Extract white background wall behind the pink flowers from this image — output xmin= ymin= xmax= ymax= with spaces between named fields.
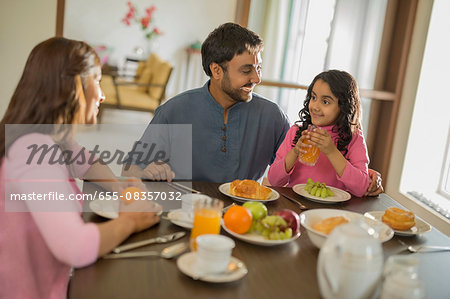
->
xmin=64 ymin=0 xmax=236 ymax=97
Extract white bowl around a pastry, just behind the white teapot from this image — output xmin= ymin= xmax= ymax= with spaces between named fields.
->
xmin=300 ymin=209 xmax=394 ymax=248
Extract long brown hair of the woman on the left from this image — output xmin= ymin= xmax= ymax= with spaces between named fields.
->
xmin=0 ymin=37 xmax=100 ymax=160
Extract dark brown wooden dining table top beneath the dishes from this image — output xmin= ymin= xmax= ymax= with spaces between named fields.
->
xmin=68 ymin=181 xmax=450 ymax=299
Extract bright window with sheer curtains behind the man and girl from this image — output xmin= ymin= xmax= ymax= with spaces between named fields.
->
xmin=248 ymin=0 xmax=387 ymax=132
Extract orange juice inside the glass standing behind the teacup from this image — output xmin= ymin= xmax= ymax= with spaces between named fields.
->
xmin=190 ymin=209 xmax=220 ymax=251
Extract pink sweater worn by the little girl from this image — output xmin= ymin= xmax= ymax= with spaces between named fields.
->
xmin=268 ymin=125 xmax=369 ymax=197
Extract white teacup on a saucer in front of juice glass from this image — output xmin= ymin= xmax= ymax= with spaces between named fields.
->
xmin=196 ymin=234 xmax=235 ymax=274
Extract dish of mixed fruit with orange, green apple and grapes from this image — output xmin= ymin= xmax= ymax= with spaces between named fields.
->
xmin=222 ymin=202 xmax=300 ymax=246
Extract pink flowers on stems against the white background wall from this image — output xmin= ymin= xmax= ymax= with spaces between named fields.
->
xmin=121 ymin=2 xmax=163 ymax=54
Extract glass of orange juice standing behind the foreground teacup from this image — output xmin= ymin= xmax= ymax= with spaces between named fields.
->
xmin=190 ymin=197 xmax=223 ymax=251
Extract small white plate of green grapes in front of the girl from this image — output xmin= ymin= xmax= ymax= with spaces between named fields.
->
xmin=292 ymin=179 xmax=352 ymax=203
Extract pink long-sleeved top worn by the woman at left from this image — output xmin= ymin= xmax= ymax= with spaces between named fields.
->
xmin=0 ymin=133 xmax=100 ymax=298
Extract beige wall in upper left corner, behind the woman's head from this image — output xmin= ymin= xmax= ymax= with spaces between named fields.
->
xmin=0 ymin=0 xmax=57 ymax=117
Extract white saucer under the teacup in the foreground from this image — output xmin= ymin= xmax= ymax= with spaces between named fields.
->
xmin=177 ymin=252 xmax=248 ymax=283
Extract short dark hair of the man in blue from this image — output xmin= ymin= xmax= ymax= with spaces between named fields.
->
xmin=202 ymin=23 xmax=263 ymax=77
